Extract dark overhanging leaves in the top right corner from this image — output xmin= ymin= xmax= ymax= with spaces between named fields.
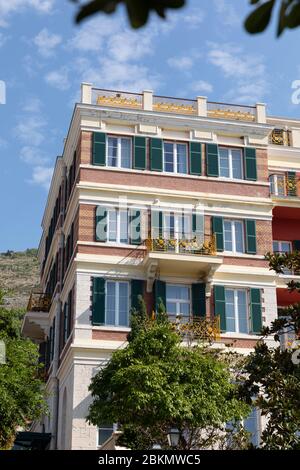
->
xmin=245 ymin=0 xmax=300 ymax=37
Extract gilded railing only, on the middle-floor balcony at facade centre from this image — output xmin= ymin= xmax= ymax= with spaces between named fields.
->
xmin=146 ymin=235 xmax=217 ymax=255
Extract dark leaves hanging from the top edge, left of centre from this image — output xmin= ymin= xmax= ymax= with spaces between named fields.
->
xmin=72 ymin=0 xmax=185 ymax=28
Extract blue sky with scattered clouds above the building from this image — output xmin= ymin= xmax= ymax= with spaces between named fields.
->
xmin=0 ymin=0 xmax=300 ymax=252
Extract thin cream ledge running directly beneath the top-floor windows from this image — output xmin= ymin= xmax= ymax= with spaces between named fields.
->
xmin=80 ymin=164 xmax=270 ymax=188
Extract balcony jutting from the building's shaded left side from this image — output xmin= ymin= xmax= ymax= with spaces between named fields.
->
xmin=22 ymin=292 xmax=51 ymax=342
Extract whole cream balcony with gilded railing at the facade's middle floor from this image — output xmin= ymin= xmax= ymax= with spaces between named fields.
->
xmin=144 ymin=235 xmax=222 ymax=286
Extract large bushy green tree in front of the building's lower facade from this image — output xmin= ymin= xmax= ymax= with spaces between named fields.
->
xmin=88 ymin=312 xmax=249 ymax=449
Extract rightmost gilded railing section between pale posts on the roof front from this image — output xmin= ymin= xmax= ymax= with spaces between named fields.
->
xmin=207 ymin=101 xmax=256 ymax=122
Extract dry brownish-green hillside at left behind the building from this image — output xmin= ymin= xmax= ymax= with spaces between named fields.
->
xmin=0 ymin=248 xmax=39 ymax=308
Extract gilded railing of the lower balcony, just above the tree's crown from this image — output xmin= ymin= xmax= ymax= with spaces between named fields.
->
xmin=168 ymin=315 xmax=221 ymax=342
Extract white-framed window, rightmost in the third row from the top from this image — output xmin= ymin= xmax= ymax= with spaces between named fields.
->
xmin=225 ymin=289 xmax=249 ymax=333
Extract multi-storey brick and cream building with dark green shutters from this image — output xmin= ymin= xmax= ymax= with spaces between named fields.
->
xmin=23 ymin=84 xmax=300 ymax=449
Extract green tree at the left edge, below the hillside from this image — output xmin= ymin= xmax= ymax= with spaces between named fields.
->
xmin=0 ymin=291 xmax=46 ymax=449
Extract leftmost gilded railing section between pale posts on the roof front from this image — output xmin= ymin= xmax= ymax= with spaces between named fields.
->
xmin=92 ymin=88 xmax=143 ymax=109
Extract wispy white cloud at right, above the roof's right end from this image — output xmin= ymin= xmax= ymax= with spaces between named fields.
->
xmin=207 ymin=43 xmax=268 ymax=104
